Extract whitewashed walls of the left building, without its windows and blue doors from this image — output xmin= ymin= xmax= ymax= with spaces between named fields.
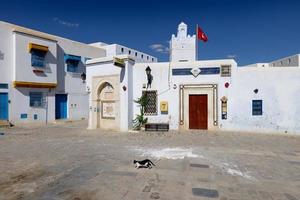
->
xmin=0 ymin=21 xmax=105 ymax=123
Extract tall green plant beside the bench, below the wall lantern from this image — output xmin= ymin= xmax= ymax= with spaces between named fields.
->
xmin=133 ymin=93 xmax=149 ymax=130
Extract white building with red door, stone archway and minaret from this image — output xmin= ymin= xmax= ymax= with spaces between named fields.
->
xmin=87 ymin=23 xmax=300 ymax=133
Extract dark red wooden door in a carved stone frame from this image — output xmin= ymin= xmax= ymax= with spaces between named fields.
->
xmin=189 ymin=94 xmax=207 ymax=130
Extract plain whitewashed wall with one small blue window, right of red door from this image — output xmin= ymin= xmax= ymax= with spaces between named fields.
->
xmin=222 ymin=67 xmax=300 ymax=133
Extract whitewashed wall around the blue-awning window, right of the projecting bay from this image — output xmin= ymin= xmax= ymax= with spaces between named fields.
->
xmin=56 ymin=38 xmax=105 ymax=120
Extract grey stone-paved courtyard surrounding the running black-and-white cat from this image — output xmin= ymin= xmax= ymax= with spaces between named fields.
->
xmin=0 ymin=121 xmax=300 ymax=200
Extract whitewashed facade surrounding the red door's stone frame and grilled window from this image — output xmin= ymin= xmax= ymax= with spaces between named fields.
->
xmin=133 ymin=59 xmax=237 ymax=130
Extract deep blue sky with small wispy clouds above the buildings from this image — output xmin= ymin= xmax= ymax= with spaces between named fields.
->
xmin=0 ymin=0 xmax=300 ymax=66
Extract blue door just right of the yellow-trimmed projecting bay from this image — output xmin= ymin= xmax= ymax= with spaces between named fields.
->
xmin=55 ymin=94 xmax=68 ymax=119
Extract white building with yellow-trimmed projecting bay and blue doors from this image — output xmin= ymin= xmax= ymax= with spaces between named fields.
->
xmin=0 ymin=21 xmax=157 ymax=124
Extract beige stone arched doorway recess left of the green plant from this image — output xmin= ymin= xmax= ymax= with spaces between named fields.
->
xmin=97 ymin=82 xmax=116 ymax=129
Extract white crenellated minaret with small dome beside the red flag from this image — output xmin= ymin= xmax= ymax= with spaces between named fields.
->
xmin=170 ymin=22 xmax=197 ymax=62
